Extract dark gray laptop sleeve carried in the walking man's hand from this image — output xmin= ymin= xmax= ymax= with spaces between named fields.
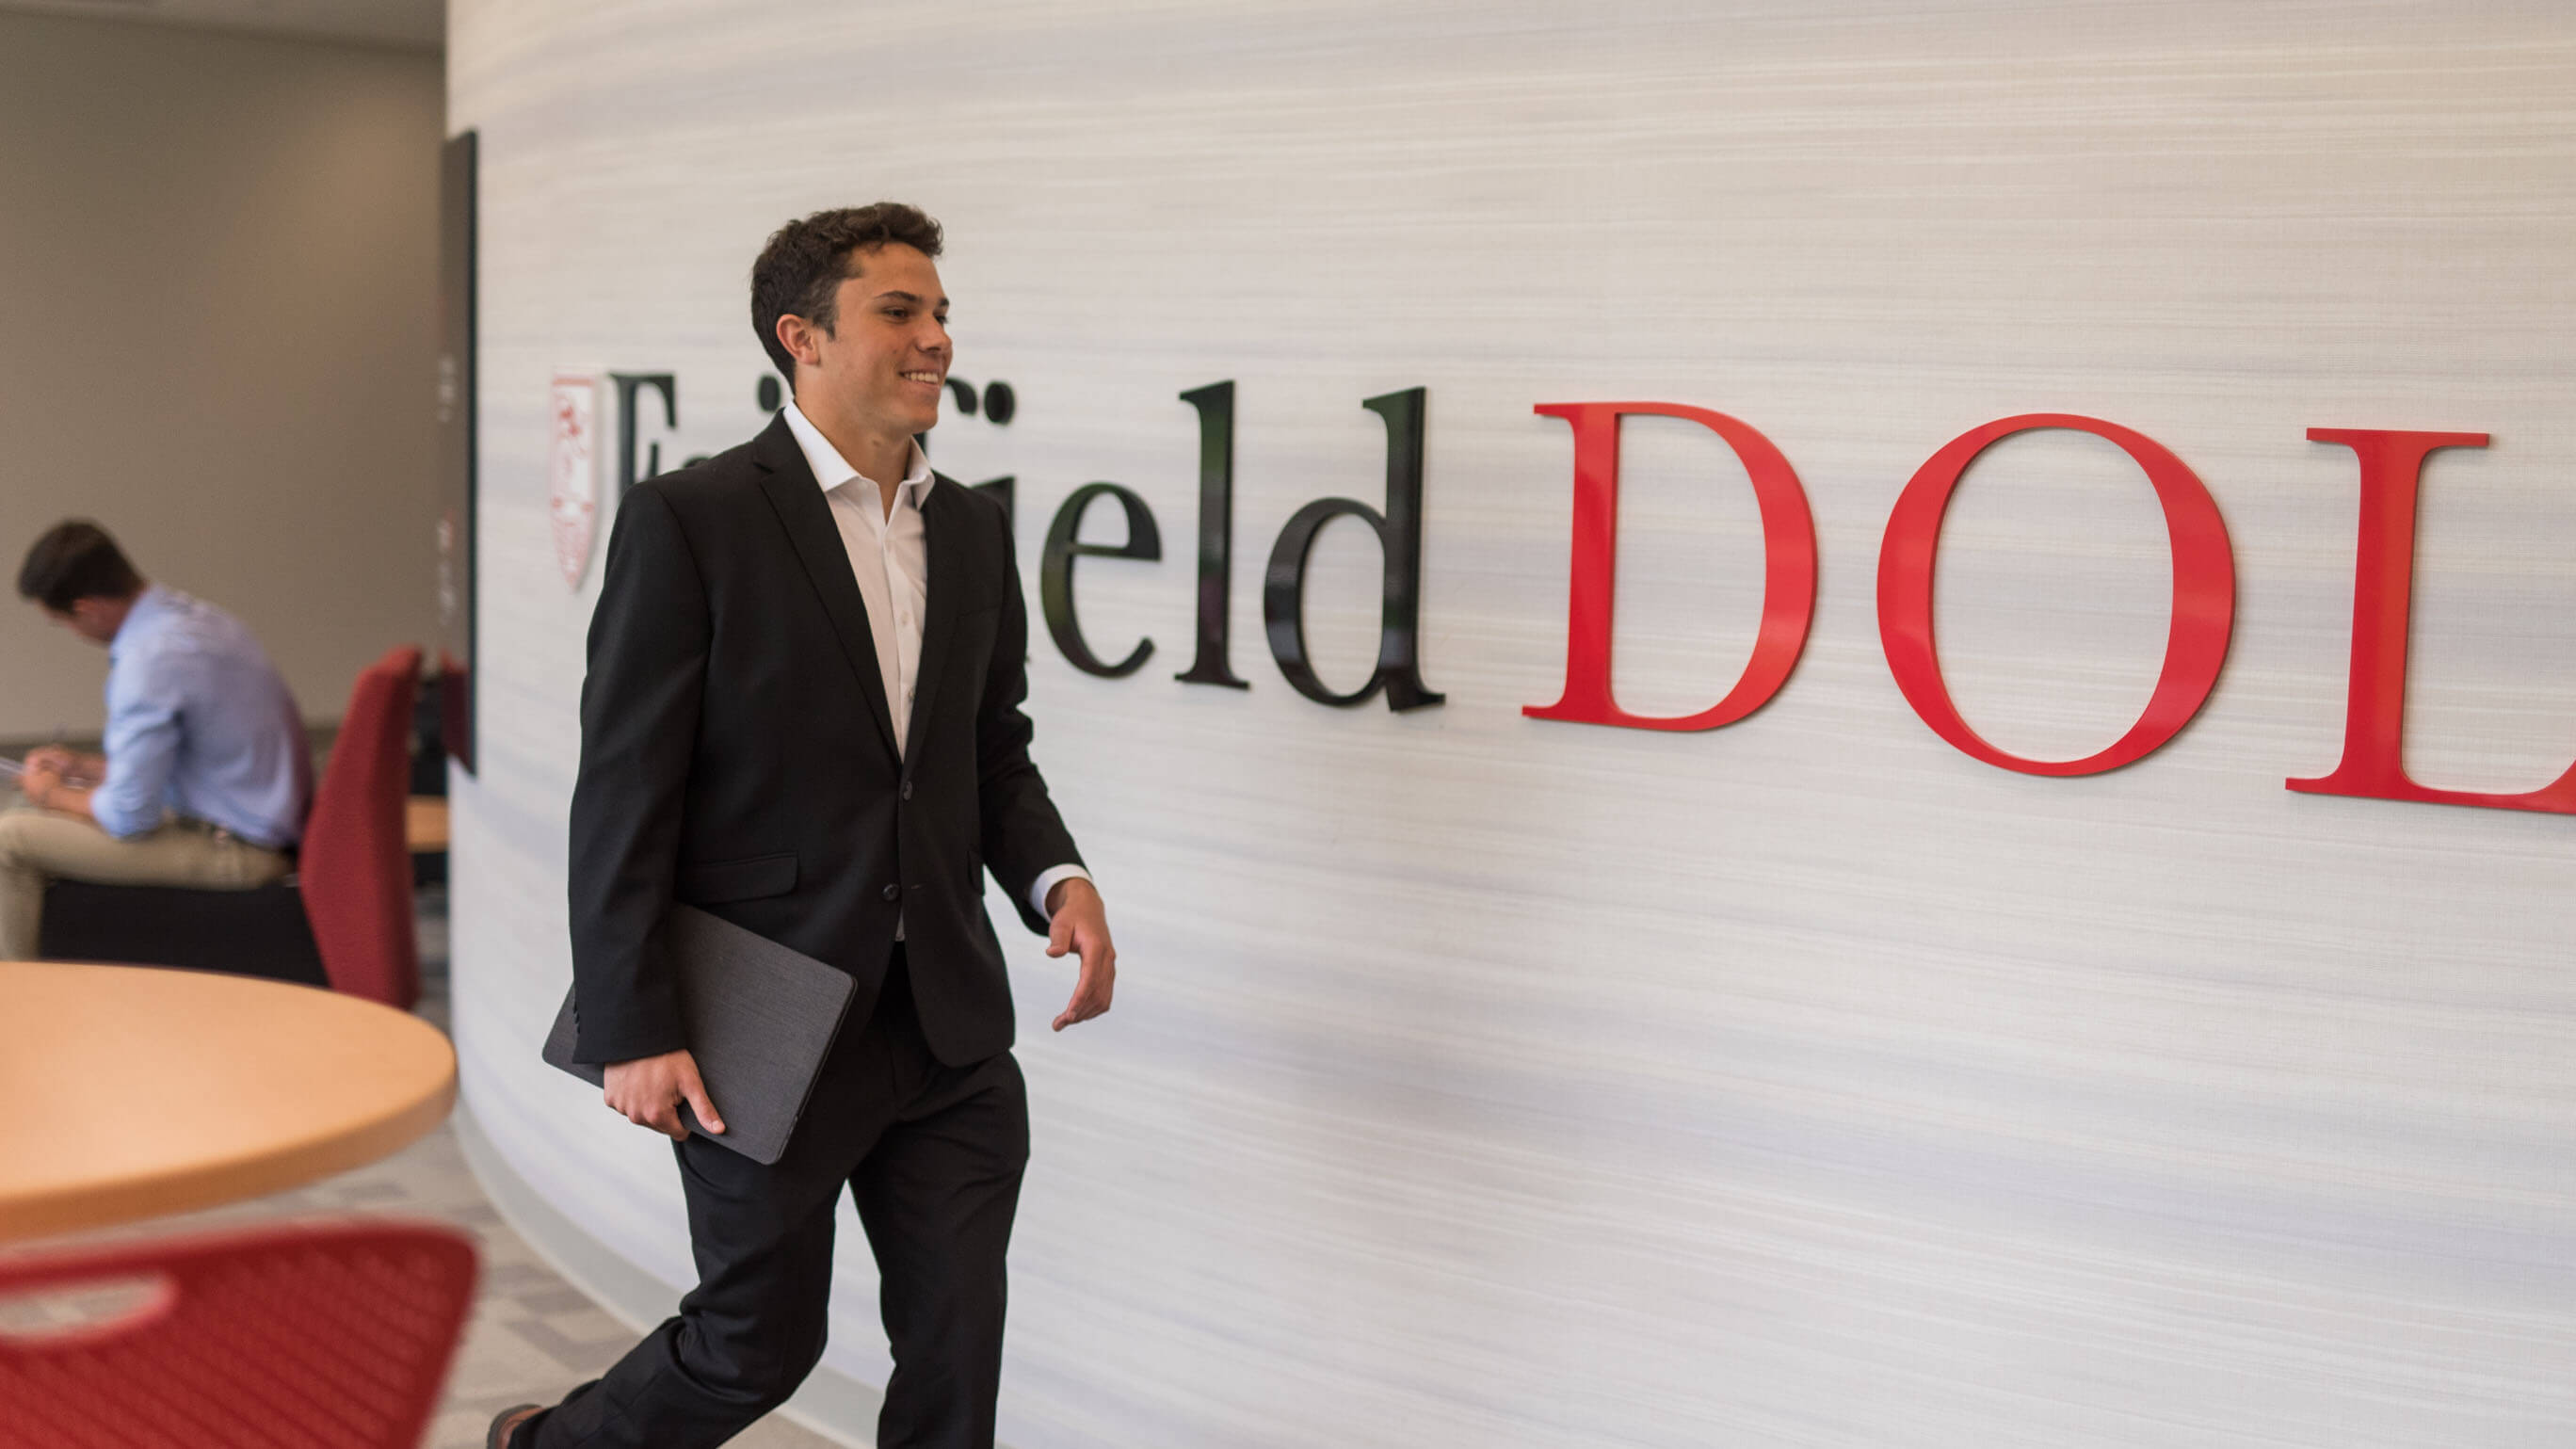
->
xmin=546 ymin=905 xmax=858 ymax=1163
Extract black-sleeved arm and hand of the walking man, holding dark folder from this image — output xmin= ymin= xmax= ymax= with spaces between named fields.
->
xmin=567 ymin=485 xmax=724 ymax=1137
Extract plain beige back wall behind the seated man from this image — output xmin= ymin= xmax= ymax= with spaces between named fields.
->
xmin=0 ymin=15 xmax=443 ymax=740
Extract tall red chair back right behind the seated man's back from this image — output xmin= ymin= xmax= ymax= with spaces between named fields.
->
xmin=297 ymin=645 xmax=420 ymax=1010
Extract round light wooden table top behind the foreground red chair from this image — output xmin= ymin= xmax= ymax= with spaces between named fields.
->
xmin=0 ymin=961 xmax=456 ymax=1243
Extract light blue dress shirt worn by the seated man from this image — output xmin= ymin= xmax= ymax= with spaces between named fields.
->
xmin=90 ymin=586 xmax=314 ymax=851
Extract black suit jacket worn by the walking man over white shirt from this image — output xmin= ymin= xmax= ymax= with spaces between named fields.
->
xmin=570 ymin=418 xmax=1082 ymax=1065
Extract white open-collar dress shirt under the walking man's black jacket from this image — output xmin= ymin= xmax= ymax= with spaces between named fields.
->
xmin=783 ymin=402 xmax=1092 ymax=912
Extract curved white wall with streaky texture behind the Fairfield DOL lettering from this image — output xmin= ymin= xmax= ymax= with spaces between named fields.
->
xmin=448 ymin=0 xmax=2576 ymax=1449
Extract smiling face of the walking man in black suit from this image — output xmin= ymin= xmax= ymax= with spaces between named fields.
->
xmin=798 ymin=242 xmax=948 ymax=436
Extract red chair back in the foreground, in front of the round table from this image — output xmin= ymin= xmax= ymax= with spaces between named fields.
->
xmin=0 ymin=1222 xmax=474 ymax=1449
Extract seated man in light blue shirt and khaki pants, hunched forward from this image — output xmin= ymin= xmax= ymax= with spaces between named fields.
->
xmin=0 ymin=521 xmax=312 ymax=961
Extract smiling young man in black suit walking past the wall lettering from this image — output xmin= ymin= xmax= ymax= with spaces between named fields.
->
xmin=492 ymin=203 xmax=1116 ymax=1449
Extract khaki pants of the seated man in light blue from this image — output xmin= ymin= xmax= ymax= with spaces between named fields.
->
xmin=0 ymin=804 xmax=286 ymax=961
